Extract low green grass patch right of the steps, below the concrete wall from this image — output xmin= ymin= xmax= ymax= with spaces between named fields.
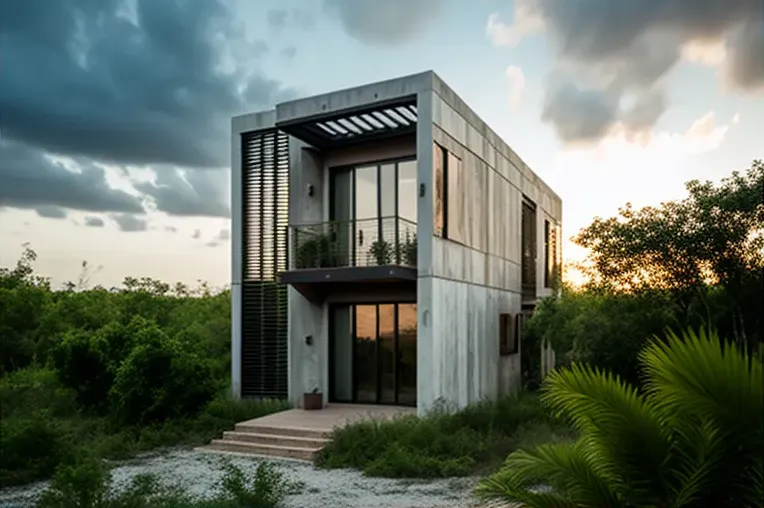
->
xmin=318 ymin=394 xmax=567 ymax=478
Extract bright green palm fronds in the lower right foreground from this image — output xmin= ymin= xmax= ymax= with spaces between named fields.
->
xmin=477 ymin=329 xmax=764 ymax=508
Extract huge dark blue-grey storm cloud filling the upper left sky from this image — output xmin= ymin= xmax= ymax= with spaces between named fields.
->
xmin=0 ymin=0 xmax=294 ymax=171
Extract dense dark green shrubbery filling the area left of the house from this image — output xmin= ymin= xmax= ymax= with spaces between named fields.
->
xmin=0 ymin=253 xmax=284 ymax=486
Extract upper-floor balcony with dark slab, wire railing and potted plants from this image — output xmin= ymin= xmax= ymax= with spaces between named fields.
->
xmin=281 ymin=216 xmax=417 ymax=302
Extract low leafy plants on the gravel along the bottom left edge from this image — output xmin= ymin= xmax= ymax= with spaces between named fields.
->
xmin=36 ymin=459 xmax=303 ymax=508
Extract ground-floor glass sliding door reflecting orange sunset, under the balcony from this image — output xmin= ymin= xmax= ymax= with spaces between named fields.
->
xmin=329 ymin=303 xmax=417 ymax=406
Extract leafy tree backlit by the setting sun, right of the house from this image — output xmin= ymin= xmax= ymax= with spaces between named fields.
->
xmin=574 ymin=161 xmax=764 ymax=346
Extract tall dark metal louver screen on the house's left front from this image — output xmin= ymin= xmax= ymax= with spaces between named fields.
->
xmin=241 ymin=129 xmax=289 ymax=398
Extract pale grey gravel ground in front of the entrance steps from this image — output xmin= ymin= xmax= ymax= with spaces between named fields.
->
xmin=0 ymin=450 xmax=490 ymax=508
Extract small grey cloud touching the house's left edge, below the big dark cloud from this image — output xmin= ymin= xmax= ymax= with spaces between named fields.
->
xmin=133 ymin=168 xmax=231 ymax=217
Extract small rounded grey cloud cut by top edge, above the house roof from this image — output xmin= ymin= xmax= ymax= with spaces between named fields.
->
xmin=324 ymin=0 xmax=445 ymax=45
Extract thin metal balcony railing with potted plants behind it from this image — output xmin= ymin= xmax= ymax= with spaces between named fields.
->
xmin=289 ymin=217 xmax=417 ymax=270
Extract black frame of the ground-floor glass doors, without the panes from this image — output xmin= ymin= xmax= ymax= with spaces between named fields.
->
xmin=328 ymin=300 xmax=419 ymax=407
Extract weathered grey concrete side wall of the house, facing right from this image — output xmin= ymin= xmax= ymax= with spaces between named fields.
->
xmin=418 ymin=74 xmax=562 ymax=414
